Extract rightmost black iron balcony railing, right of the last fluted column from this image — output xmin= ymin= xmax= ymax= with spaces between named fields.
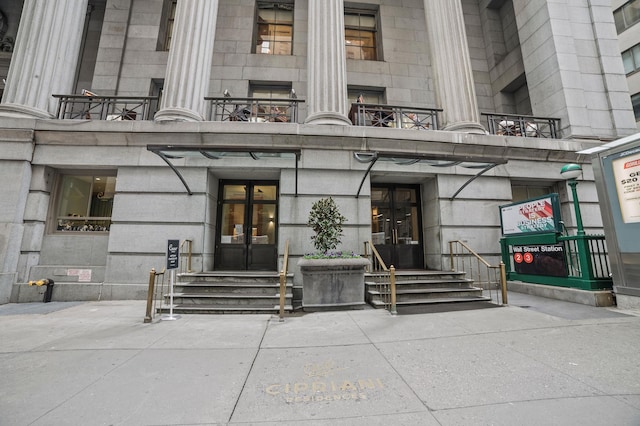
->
xmin=482 ymin=113 xmax=560 ymax=139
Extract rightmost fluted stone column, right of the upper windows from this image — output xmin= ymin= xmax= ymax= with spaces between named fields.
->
xmin=424 ymin=0 xmax=485 ymax=133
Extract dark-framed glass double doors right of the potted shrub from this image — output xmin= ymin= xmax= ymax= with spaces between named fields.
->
xmin=371 ymin=185 xmax=424 ymax=269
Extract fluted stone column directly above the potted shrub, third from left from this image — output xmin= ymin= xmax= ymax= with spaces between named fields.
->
xmin=306 ymin=0 xmax=351 ymax=125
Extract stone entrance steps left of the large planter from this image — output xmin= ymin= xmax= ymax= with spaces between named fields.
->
xmin=159 ymin=271 xmax=293 ymax=314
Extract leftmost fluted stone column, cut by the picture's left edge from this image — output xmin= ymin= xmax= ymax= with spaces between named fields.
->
xmin=0 ymin=0 xmax=88 ymax=118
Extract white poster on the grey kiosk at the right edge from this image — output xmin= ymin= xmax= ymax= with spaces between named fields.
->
xmin=611 ymin=153 xmax=640 ymax=223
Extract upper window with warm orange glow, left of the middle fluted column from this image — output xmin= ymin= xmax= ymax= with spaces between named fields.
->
xmin=255 ymin=1 xmax=293 ymax=55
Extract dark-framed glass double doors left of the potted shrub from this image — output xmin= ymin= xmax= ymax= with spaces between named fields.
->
xmin=215 ymin=181 xmax=278 ymax=271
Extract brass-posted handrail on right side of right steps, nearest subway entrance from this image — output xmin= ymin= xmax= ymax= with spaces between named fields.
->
xmin=449 ymin=240 xmax=507 ymax=305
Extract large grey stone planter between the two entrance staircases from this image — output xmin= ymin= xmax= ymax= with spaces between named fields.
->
xmin=298 ymin=258 xmax=369 ymax=311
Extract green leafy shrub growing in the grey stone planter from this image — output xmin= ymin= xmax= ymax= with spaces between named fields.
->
xmin=307 ymin=197 xmax=347 ymax=253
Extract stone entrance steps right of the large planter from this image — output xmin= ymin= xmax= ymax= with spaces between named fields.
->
xmin=365 ymin=270 xmax=491 ymax=309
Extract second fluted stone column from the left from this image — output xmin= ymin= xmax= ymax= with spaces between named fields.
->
xmin=155 ymin=0 xmax=218 ymax=121
